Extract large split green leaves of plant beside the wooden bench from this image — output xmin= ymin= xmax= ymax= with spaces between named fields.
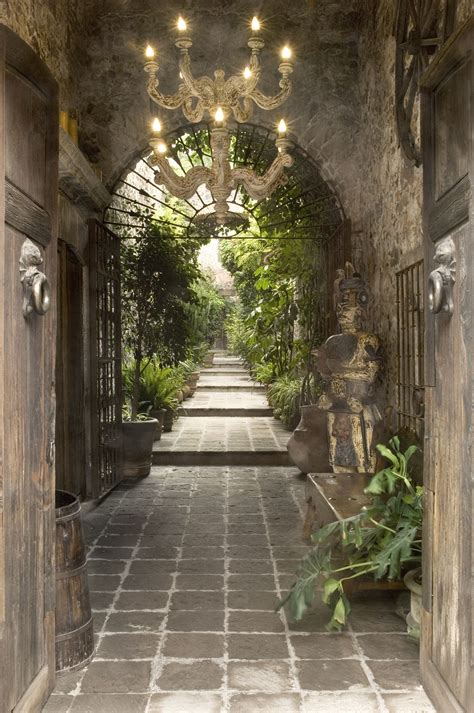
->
xmin=279 ymin=436 xmax=423 ymax=631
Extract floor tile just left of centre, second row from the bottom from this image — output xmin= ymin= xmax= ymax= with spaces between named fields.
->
xmin=155 ymin=661 xmax=224 ymax=691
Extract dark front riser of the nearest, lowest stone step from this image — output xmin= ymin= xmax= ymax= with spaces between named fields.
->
xmin=152 ymin=450 xmax=291 ymax=466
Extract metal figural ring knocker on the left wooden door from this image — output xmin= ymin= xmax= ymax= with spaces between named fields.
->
xmin=19 ymin=238 xmax=51 ymax=317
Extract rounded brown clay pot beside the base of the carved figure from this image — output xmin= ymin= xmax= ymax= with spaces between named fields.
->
xmin=287 ymin=404 xmax=332 ymax=473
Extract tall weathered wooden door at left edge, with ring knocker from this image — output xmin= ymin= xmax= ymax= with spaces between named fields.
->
xmin=0 ymin=26 xmax=58 ymax=713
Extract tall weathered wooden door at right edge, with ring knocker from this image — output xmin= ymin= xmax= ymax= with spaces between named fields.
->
xmin=421 ymin=18 xmax=474 ymax=713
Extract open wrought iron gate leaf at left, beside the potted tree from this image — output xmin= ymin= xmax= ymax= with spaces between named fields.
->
xmin=89 ymin=220 xmax=122 ymax=498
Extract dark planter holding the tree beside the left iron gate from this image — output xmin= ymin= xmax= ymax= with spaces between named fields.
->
xmin=122 ymin=418 xmax=158 ymax=478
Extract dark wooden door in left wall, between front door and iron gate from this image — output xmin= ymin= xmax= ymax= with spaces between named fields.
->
xmin=56 ymin=240 xmax=87 ymax=499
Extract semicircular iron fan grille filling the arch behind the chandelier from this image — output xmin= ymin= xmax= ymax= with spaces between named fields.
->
xmin=105 ymin=123 xmax=344 ymax=241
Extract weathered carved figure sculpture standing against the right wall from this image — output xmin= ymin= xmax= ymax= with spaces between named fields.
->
xmin=314 ymin=263 xmax=381 ymax=473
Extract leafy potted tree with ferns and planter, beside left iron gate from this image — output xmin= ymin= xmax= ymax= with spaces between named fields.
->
xmin=120 ymin=215 xmax=201 ymax=476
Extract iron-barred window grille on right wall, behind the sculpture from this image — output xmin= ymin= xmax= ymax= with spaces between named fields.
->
xmin=396 ymin=260 xmax=425 ymax=436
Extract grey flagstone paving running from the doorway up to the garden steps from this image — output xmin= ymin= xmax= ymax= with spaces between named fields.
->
xmin=44 ymin=361 xmax=434 ymax=713
